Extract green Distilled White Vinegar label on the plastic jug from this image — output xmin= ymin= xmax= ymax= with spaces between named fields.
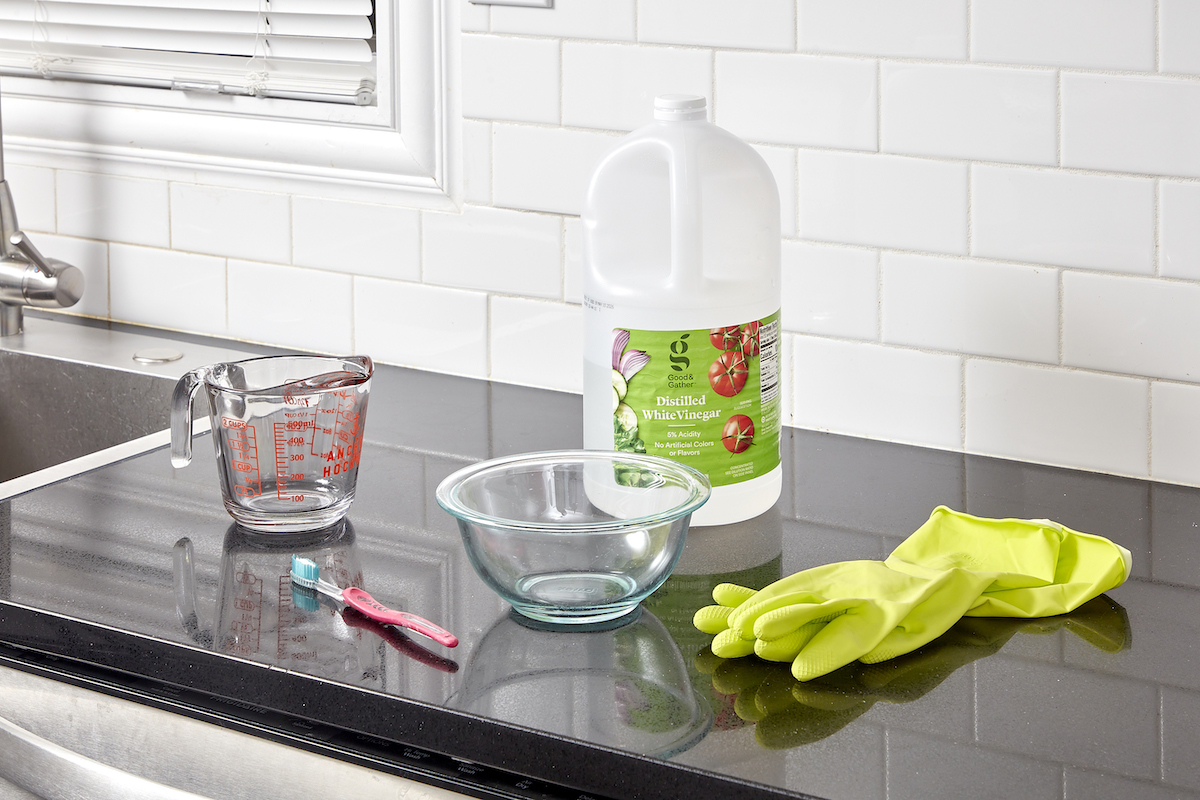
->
xmin=612 ymin=312 xmax=780 ymax=486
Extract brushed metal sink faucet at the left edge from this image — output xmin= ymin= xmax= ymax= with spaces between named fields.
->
xmin=0 ymin=89 xmax=83 ymax=336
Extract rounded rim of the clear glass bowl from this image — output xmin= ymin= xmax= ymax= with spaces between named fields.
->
xmin=436 ymin=450 xmax=713 ymax=535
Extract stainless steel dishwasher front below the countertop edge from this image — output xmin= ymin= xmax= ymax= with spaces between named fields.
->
xmin=0 ymin=667 xmax=466 ymax=800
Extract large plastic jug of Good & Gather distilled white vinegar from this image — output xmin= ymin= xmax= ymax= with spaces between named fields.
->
xmin=582 ymin=95 xmax=782 ymax=525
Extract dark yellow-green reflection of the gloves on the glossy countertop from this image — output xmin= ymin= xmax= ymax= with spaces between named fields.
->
xmin=696 ymin=595 xmax=1132 ymax=750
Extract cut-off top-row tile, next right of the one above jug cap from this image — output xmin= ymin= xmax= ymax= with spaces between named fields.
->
xmin=798 ymin=0 xmax=967 ymax=60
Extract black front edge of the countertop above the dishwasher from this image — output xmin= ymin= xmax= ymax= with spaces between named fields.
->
xmin=0 ymin=601 xmax=815 ymax=800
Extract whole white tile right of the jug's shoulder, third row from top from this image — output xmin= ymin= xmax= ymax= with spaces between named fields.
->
xmin=798 ymin=150 xmax=967 ymax=254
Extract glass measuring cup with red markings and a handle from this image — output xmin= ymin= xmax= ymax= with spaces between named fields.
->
xmin=170 ymin=355 xmax=374 ymax=533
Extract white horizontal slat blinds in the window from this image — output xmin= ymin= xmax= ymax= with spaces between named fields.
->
xmin=0 ymin=0 xmax=376 ymax=104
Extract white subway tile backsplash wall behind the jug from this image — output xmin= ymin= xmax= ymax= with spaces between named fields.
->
xmin=8 ymin=0 xmax=1200 ymax=485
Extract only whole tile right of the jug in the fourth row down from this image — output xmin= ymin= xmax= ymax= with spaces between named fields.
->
xmin=881 ymin=253 xmax=1058 ymax=362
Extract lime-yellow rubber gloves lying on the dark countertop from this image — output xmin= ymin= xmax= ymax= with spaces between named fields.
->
xmin=694 ymin=506 xmax=1130 ymax=680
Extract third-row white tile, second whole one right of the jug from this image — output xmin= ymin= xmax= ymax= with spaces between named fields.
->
xmin=971 ymin=166 xmax=1154 ymax=275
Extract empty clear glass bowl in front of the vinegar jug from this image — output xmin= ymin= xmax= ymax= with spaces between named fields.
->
xmin=437 ymin=450 xmax=712 ymax=624
